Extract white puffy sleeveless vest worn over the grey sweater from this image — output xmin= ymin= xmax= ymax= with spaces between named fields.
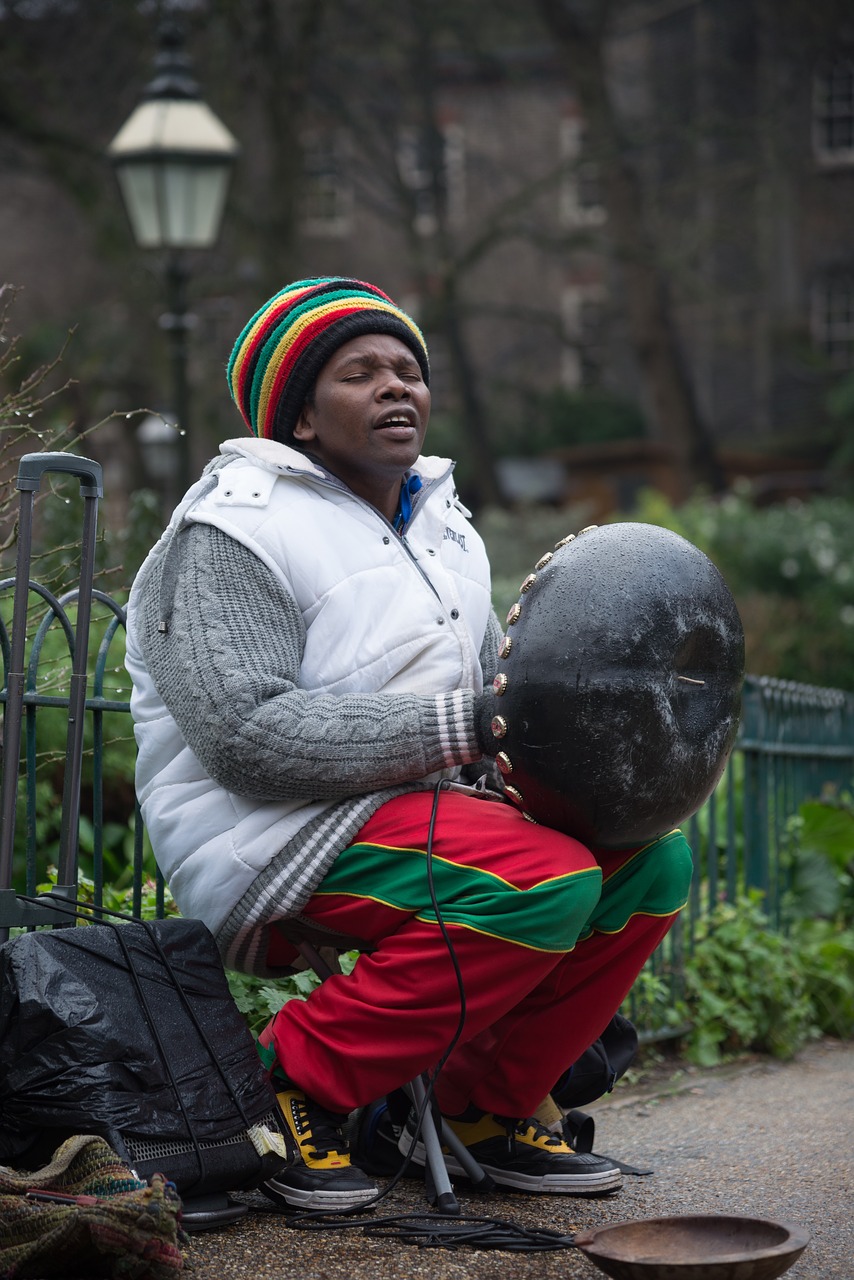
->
xmin=127 ymin=439 xmax=490 ymax=933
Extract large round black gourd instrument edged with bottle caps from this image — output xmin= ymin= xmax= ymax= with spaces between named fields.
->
xmin=492 ymin=522 xmax=744 ymax=847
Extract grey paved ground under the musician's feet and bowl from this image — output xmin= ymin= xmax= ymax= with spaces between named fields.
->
xmin=188 ymin=1042 xmax=854 ymax=1280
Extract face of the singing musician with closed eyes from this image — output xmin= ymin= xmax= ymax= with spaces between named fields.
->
xmin=293 ymin=333 xmax=430 ymax=520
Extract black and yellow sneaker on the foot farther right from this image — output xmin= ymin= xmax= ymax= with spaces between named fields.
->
xmin=399 ymin=1107 xmax=622 ymax=1196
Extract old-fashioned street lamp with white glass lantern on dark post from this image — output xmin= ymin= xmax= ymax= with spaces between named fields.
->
xmin=108 ymin=22 xmax=238 ymax=493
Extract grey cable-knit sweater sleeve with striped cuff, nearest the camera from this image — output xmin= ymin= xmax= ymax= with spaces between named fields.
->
xmin=136 ymin=525 xmax=491 ymax=800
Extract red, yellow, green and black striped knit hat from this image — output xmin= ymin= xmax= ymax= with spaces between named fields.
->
xmin=227 ymin=275 xmax=430 ymax=444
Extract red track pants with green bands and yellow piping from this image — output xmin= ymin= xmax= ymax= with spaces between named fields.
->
xmin=270 ymin=791 xmax=691 ymax=1116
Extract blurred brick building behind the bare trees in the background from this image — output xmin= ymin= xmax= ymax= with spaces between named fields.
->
xmin=0 ymin=0 xmax=854 ymax=508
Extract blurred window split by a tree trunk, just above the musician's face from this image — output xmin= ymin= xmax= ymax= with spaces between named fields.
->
xmin=397 ymin=124 xmax=466 ymax=236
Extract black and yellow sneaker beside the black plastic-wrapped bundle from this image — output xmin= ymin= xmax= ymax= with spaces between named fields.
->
xmin=260 ymin=1079 xmax=379 ymax=1212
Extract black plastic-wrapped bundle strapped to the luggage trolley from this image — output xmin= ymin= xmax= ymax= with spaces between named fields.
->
xmin=0 ymin=919 xmax=287 ymax=1196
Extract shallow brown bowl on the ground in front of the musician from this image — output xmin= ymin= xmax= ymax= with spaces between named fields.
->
xmin=575 ymin=1213 xmax=809 ymax=1280
